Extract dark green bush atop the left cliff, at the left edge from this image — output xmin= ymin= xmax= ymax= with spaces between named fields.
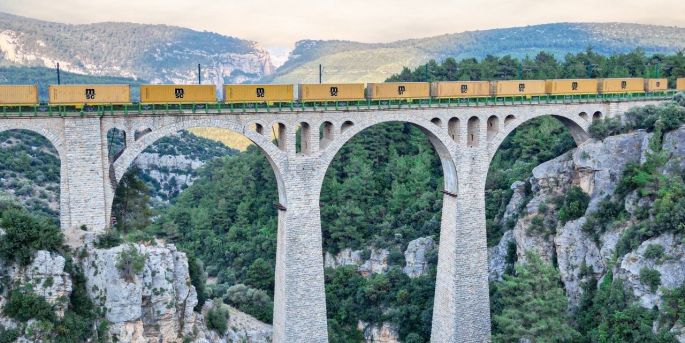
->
xmin=0 ymin=209 xmax=64 ymax=266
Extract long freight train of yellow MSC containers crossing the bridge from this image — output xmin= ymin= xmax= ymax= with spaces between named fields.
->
xmin=0 ymin=78 xmax=685 ymax=112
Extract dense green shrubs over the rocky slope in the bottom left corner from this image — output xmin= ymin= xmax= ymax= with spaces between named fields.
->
xmin=0 ymin=193 xmax=108 ymax=343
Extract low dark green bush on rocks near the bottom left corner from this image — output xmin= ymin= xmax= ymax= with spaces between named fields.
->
xmin=2 ymin=289 xmax=56 ymax=322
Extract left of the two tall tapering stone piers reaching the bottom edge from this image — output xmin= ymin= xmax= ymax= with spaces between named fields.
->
xmin=273 ymin=161 xmax=328 ymax=343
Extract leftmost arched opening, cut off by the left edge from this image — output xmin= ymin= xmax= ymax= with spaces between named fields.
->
xmin=0 ymin=129 xmax=60 ymax=225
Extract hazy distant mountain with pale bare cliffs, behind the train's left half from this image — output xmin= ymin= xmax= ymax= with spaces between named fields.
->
xmin=0 ymin=13 xmax=275 ymax=89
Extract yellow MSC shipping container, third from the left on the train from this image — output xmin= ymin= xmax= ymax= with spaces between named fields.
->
xmin=140 ymin=85 xmax=216 ymax=104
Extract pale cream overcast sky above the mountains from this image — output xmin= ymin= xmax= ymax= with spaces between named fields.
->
xmin=0 ymin=0 xmax=685 ymax=48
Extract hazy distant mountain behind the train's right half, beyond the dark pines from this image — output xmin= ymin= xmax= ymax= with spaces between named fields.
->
xmin=264 ymin=23 xmax=685 ymax=83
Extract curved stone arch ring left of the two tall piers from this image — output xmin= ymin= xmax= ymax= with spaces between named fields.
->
xmin=111 ymin=118 xmax=287 ymax=212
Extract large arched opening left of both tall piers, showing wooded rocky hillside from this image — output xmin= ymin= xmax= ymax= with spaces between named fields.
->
xmin=111 ymin=125 xmax=287 ymax=330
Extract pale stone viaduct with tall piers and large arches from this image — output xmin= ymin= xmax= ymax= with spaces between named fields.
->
xmin=0 ymin=101 xmax=656 ymax=343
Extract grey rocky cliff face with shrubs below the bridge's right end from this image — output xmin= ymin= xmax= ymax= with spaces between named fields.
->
xmin=490 ymin=127 xmax=685 ymax=326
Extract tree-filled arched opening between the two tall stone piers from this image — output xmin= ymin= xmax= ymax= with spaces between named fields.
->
xmin=320 ymin=121 xmax=457 ymax=342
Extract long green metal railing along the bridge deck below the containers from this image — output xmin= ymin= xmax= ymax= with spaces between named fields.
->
xmin=1 ymin=91 xmax=678 ymax=117
